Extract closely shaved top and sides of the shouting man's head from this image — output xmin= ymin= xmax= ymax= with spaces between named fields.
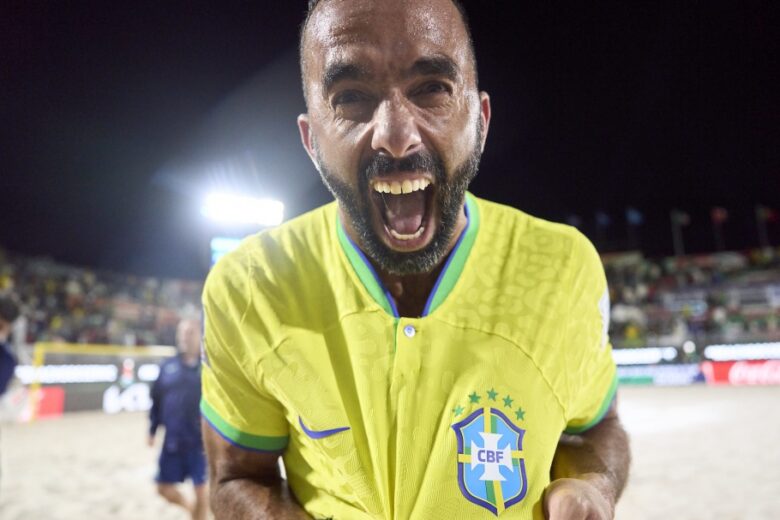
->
xmin=299 ymin=0 xmax=478 ymax=106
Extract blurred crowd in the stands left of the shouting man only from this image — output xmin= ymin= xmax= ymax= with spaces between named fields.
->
xmin=0 ymin=249 xmax=202 ymax=346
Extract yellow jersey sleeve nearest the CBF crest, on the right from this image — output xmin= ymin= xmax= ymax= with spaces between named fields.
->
xmin=565 ymin=233 xmax=617 ymax=434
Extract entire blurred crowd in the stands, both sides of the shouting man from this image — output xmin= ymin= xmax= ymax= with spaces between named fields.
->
xmin=0 ymin=245 xmax=780 ymax=348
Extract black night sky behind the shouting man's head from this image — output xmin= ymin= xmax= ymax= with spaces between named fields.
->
xmin=0 ymin=0 xmax=780 ymax=278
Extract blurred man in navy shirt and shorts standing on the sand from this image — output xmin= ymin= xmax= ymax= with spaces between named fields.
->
xmin=149 ymin=319 xmax=208 ymax=520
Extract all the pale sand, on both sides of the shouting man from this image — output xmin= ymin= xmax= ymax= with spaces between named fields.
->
xmin=0 ymin=386 xmax=780 ymax=520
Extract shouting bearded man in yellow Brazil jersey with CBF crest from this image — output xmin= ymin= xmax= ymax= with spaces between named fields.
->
xmin=201 ymin=0 xmax=629 ymax=520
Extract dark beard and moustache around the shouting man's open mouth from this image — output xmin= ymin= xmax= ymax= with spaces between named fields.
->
xmin=312 ymin=120 xmax=482 ymax=275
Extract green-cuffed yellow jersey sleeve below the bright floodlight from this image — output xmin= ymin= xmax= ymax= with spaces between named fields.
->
xmin=200 ymin=257 xmax=288 ymax=452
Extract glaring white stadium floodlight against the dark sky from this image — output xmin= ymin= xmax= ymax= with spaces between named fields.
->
xmin=200 ymin=193 xmax=284 ymax=226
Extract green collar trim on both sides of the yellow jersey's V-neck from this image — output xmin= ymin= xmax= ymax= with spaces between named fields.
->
xmin=336 ymin=193 xmax=479 ymax=318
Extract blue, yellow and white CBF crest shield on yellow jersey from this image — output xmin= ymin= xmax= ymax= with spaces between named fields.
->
xmin=452 ymin=406 xmax=528 ymax=516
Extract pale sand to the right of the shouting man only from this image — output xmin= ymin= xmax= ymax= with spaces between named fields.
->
xmin=617 ymin=386 xmax=780 ymax=520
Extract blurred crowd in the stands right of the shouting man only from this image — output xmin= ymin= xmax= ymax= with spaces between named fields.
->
xmin=603 ymin=249 xmax=780 ymax=347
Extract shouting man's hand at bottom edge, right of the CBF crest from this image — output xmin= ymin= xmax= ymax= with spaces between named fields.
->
xmin=544 ymin=478 xmax=614 ymax=520
